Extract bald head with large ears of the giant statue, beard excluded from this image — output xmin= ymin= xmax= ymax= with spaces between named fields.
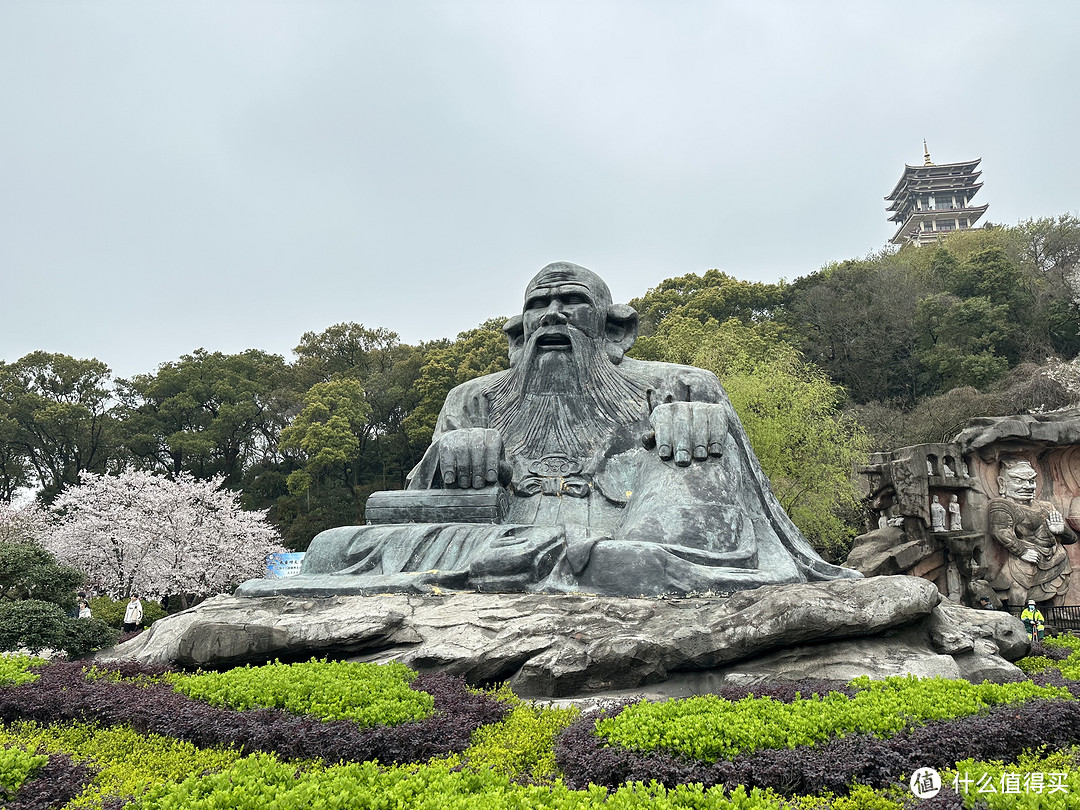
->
xmin=503 ymin=261 xmax=637 ymax=363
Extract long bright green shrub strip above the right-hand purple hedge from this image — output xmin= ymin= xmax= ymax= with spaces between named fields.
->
xmin=596 ymin=677 xmax=1071 ymax=762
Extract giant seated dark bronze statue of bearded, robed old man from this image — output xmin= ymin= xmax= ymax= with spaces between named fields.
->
xmin=238 ymin=262 xmax=861 ymax=596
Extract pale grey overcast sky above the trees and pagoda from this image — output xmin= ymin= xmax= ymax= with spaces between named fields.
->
xmin=0 ymin=0 xmax=1080 ymax=376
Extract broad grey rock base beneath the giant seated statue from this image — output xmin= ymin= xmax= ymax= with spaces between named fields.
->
xmin=97 ymin=577 xmax=1028 ymax=699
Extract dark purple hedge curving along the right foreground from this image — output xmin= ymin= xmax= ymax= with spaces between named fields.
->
xmin=555 ymin=700 xmax=1080 ymax=795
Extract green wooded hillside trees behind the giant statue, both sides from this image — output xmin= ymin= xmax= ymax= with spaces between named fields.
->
xmin=0 ymin=214 xmax=1080 ymax=550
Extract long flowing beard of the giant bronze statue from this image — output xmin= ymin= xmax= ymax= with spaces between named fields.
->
xmin=487 ymin=328 xmax=647 ymax=460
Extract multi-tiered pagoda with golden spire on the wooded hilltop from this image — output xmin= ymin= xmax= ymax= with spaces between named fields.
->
xmin=886 ymin=140 xmax=989 ymax=245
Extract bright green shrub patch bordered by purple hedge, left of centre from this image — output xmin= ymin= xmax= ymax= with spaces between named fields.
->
xmin=167 ymin=659 xmax=434 ymax=727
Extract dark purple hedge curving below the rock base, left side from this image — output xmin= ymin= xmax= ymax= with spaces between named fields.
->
xmin=0 ymin=662 xmax=508 ymax=762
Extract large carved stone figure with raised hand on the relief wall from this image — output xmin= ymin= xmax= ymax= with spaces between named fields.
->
xmin=987 ymin=459 xmax=1077 ymax=605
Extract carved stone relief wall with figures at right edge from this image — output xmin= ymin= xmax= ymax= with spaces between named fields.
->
xmin=848 ymin=409 xmax=1080 ymax=607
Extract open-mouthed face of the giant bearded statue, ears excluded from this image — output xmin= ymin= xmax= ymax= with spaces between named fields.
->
xmin=522 ymin=279 xmax=607 ymax=352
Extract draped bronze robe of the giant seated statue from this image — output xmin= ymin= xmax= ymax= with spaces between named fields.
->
xmin=238 ymin=359 xmax=860 ymax=596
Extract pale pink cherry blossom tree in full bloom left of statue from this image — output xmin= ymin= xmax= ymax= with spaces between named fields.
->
xmin=45 ymin=471 xmax=282 ymax=597
